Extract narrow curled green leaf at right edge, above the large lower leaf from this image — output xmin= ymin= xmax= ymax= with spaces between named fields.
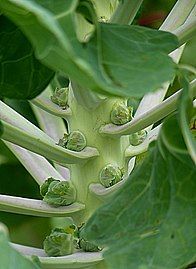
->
xmin=179 ymin=77 xmax=196 ymax=164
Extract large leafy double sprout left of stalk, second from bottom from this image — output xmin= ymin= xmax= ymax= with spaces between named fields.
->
xmin=40 ymin=178 xmax=76 ymax=207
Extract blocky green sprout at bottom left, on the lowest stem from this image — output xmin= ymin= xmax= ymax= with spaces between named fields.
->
xmin=44 ymin=228 xmax=74 ymax=257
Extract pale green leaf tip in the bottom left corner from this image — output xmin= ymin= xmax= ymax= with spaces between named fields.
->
xmin=0 ymin=232 xmax=41 ymax=269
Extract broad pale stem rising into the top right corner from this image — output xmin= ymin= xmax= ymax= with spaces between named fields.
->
xmin=160 ymin=0 xmax=195 ymax=32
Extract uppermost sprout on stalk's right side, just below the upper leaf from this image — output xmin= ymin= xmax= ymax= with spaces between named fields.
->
xmin=110 ymin=103 xmax=133 ymax=125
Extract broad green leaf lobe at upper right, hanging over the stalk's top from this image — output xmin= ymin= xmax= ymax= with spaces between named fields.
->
xmin=95 ymin=24 xmax=177 ymax=97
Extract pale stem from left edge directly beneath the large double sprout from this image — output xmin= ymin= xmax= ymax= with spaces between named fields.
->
xmin=0 ymin=194 xmax=85 ymax=217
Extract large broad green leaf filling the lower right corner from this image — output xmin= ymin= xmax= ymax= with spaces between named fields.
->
xmin=84 ymin=116 xmax=196 ymax=269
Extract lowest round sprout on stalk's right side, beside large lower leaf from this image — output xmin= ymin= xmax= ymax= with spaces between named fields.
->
xmin=100 ymin=164 xmax=123 ymax=188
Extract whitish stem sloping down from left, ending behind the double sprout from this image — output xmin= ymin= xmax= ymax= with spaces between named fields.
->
xmin=4 ymin=141 xmax=65 ymax=185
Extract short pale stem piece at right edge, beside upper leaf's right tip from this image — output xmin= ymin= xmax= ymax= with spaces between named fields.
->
xmin=173 ymin=19 xmax=196 ymax=44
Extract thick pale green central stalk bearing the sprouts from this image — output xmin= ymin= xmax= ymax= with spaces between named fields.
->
xmin=68 ymin=89 xmax=129 ymax=221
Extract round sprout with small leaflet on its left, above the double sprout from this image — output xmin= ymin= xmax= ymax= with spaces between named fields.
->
xmin=58 ymin=131 xmax=86 ymax=151
